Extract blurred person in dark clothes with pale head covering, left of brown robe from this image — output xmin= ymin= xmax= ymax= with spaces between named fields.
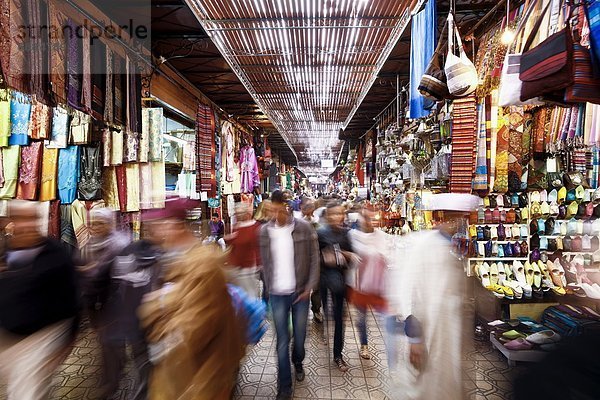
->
xmin=80 ymin=208 xmax=129 ymax=398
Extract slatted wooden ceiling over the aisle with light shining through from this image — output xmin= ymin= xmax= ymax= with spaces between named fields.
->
xmin=188 ymin=0 xmax=411 ymax=170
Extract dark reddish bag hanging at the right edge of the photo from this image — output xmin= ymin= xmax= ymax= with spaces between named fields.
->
xmin=565 ymin=8 xmax=600 ymax=104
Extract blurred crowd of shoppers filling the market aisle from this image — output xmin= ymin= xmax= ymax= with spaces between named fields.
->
xmin=0 ymin=191 xmax=480 ymax=400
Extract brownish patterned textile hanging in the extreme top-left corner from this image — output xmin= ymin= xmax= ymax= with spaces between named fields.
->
xmin=3 ymin=0 xmax=30 ymax=93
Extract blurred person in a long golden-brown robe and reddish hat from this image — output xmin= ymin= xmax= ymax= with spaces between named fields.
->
xmin=139 ymin=199 xmax=244 ymax=400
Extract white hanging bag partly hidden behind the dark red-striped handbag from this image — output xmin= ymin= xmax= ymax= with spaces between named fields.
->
xmin=498 ymin=1 xmax=542 ymax=107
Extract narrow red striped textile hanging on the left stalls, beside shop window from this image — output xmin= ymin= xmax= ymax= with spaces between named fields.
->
xmin=196 ymin=103 xmax=216 ymax=197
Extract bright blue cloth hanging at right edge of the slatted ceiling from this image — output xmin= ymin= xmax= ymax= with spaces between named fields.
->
xmin=409 ymin=0 xmax=437 ymax=118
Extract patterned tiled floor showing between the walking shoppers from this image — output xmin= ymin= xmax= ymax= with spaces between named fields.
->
xmin=0 ymin=310 xmax=514 ymax=400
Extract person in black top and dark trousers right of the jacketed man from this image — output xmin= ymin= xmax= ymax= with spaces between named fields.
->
xmin=317 ymin=201 xmax=354 ymax=372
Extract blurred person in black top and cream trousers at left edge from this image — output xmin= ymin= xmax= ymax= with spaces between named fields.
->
xmin=0 ymin=200 xmax=78 ymax=400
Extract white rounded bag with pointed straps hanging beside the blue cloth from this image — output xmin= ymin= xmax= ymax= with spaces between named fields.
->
xmin=444 ymin=13 xmax=479 ymax=97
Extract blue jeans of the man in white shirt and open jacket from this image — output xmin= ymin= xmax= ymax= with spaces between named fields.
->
xmin=269 ymin=294 xmax=309 ymax=393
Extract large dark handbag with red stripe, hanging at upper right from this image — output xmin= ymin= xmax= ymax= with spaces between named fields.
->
xmin=519 ymin=2 xmax=573 ymax=101
